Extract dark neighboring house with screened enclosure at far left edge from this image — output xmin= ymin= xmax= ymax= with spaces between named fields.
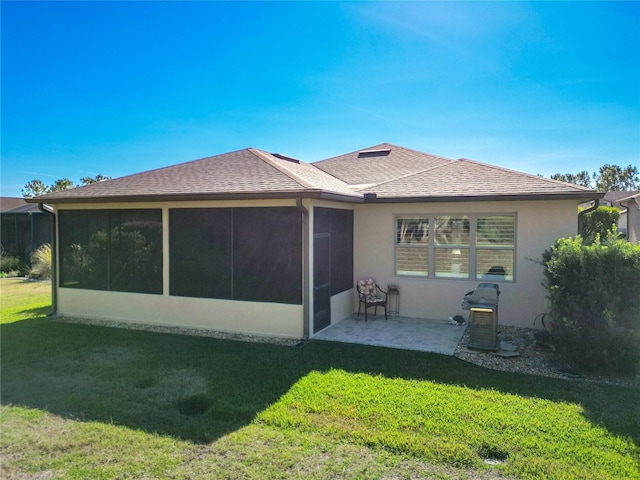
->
xmin=0 ymin=197 xmax=51 ymax=262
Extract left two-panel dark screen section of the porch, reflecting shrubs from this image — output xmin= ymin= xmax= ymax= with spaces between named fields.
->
xmin=59 ymin=209 xmax=162 ymax=294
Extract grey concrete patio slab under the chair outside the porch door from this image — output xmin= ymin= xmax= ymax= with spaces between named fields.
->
xmin=313 ymin=314 xmax=466 ymax=355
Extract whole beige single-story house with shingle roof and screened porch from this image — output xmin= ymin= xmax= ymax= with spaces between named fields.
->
xmin=29 ymin=143 xmax=602 ymax=338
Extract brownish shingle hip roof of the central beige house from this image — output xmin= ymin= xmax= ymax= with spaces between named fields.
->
xmin=28 ymin=143 xmax=602 ymax=203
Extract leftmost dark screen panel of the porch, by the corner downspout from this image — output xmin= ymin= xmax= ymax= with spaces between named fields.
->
xmin=58 ymin=210 xmax=109 ymax=290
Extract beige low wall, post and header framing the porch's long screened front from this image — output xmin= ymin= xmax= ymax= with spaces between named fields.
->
xmin=56 ymin=200 xmax=303 ymax=338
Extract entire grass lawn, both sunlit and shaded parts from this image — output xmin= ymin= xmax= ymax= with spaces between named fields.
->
xmin=0 ymin=280 xmax=640 ymax=479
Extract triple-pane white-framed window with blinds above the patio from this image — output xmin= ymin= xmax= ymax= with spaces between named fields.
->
xmin=395 ymin=215 xmax=516 ymax=281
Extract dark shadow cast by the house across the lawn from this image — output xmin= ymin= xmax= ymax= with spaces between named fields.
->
xmin=1 ymin=318 xmax=640 ymax=445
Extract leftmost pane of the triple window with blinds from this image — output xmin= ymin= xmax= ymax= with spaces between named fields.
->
xmin=395 ymin=217 xmax=429 ymax=277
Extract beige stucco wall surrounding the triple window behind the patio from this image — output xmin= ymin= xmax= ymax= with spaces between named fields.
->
xmin=354 ymin=201 xmax=578 ymax=327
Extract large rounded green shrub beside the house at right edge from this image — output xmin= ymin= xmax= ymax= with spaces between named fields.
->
xmin=543 ymin=230 xmax=640 ymax=373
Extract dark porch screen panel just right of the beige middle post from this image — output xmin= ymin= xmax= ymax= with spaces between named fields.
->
xmin=169 ymin=208 xmax=232 ymax=299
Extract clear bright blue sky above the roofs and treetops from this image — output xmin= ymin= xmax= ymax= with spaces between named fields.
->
xmin=0 ymin=1 xmax=640 ymax=196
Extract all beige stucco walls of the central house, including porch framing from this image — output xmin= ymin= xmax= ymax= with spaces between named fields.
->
xmin=52 ymin=195 xmax=577 ymax=338
